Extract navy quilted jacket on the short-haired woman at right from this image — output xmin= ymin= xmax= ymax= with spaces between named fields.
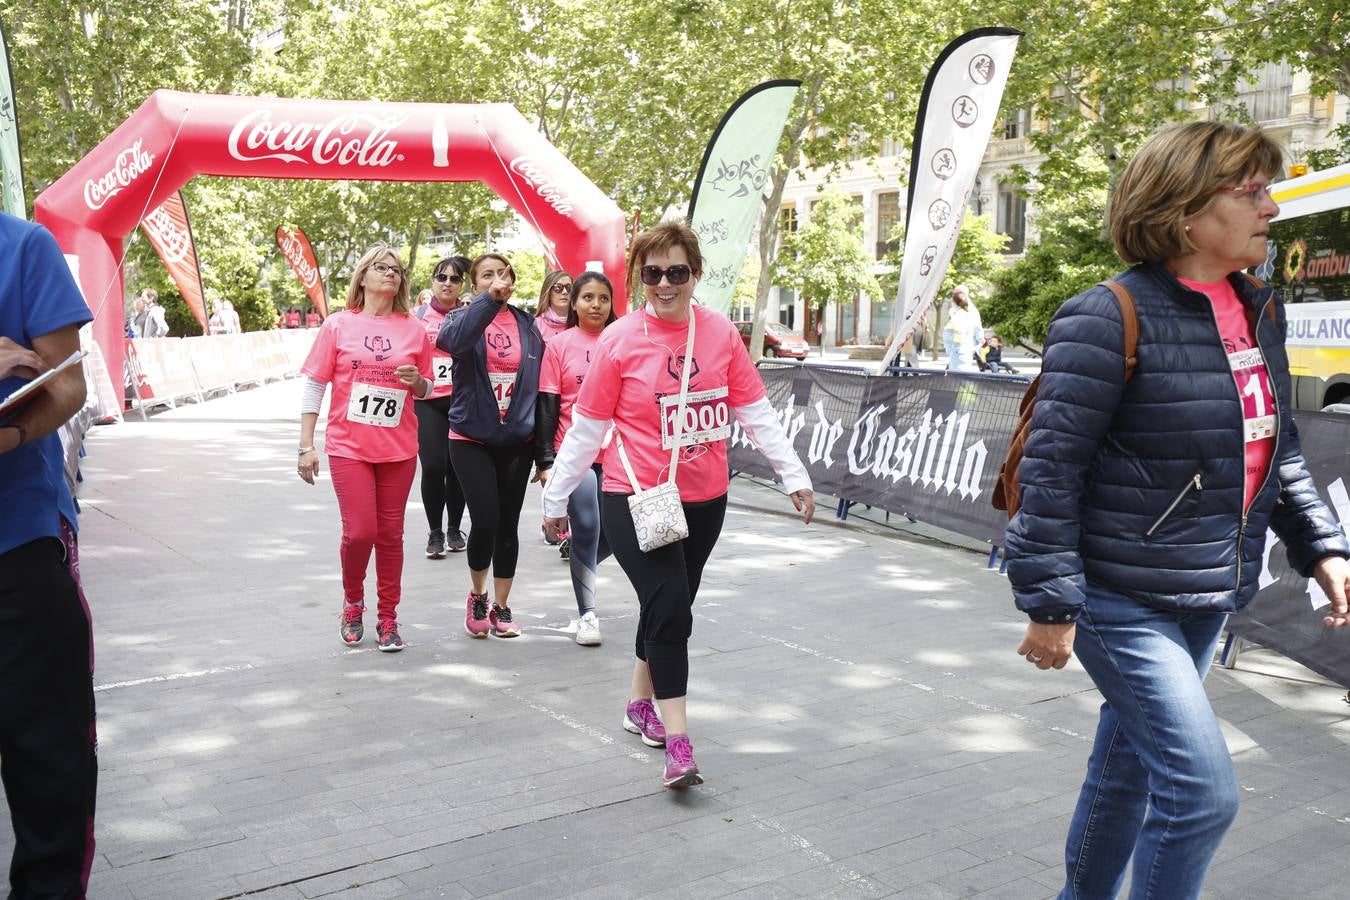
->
xmin=1004 ymin=264 xmax=1350 ymax=622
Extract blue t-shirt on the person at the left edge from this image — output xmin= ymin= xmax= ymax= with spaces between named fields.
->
xmin=0 ymin=213 xmax=93 ymax=553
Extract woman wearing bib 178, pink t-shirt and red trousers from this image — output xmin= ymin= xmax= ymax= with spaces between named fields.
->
xmin=297 ymin=244 xmax=432 ymax=652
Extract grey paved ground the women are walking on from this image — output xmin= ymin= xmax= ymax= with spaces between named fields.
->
xmin=13 ymin=382 xmax=1350 ymax=900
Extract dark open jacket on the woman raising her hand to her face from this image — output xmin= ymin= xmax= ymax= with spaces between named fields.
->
xmin=436 ymin=291 xmax=544 ymax=447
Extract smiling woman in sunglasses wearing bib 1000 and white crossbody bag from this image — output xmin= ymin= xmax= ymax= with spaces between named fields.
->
xmin=544 ymin=221 xmax=815 ymax=788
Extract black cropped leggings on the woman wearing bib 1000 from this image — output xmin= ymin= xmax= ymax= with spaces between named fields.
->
xmin=599 ymin=493 xmax=726 ymax=700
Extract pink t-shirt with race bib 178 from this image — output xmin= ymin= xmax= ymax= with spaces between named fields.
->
xmin=300 ymin=312 xmax=432 ymax=463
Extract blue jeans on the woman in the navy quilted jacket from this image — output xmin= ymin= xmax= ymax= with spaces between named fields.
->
xmin=1060 ymin=584 xmax=1238 ymax=900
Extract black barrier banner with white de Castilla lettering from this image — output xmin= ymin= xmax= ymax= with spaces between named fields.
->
xmin=729 ymin=364 xmax=1350 ymax=687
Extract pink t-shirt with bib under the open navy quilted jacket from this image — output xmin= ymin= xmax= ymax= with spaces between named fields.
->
xmin=1179 ymin=278 xmax=1280 ymax=513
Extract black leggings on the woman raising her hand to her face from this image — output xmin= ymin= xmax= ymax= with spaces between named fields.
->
xmin=450 ymin=441 xmax=535 ymax=578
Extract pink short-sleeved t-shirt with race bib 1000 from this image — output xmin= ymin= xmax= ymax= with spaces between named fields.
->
xmin=576 ymin=300 xmax=764 ymax=503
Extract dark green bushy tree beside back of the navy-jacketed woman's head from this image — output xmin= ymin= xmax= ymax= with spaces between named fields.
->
xmin=980 ymin=190 xmax=1122 ymax=344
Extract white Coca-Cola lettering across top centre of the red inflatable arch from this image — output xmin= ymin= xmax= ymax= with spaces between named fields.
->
xmin=230 ymin=109 xmax=404 ymax=167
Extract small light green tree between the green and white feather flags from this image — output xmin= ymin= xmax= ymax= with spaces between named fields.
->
xmin=776 ymin=189 xmax=882 ymax=315
